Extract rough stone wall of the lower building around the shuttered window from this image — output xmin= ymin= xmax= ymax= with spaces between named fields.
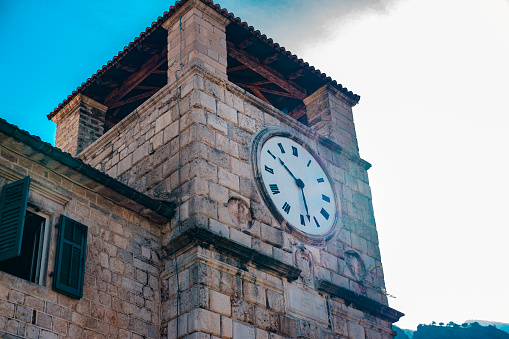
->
xmin=0 ymin=146 xmax=161 ymax=339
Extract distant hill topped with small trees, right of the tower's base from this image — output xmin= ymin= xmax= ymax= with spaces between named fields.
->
xmin=410 ymin=322 xmax=509 ymax=339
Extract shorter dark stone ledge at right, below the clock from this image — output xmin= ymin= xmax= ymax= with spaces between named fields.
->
xmin=316 ymin=280 xmax=405 ymax=323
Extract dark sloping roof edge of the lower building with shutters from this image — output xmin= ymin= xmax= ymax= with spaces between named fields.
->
xmin=0 ymin=118 xmax=175 ymax=223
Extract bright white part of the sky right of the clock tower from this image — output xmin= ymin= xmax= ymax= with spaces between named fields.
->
xmin=290 ymin=0 xmax=509 ymax=329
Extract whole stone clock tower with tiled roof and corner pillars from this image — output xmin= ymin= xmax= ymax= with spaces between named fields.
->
xmin=50 ymin=0 xmax=403 ymax=339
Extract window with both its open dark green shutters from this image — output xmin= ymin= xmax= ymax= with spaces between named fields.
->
xmin=0 ymin=177 xmax=88 ymax=299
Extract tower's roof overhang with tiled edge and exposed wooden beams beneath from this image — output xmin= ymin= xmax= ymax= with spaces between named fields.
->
xmin=47 ymin=0 xmax=360 ymax=129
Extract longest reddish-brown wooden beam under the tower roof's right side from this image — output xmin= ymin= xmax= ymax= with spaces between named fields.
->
xmin=227 ymin=41 xmax=307 ymax=100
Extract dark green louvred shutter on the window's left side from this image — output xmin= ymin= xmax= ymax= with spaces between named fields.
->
xmin=0 ymin=177 xmax=30 ymax=261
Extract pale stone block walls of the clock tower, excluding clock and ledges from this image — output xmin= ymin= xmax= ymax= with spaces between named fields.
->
xmin=77 ymin=63 xmax=391 ymax=338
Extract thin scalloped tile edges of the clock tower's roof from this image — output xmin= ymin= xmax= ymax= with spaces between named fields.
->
xmin=47 ymin=0 xmax=360 ymax=119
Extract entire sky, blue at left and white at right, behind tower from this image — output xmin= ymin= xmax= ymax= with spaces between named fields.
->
xmin=0 ymin=0 xmax=509 ymax=329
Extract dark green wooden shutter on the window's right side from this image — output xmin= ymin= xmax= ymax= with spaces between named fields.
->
xmin=53 ymin=215 xmax=88 ymax=299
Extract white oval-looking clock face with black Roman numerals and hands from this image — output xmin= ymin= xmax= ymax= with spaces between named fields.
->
xmin=259 ymin=136 xmax=336 ymax=235
